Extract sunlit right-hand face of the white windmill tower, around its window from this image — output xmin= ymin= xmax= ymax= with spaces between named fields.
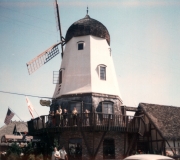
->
xmin=90 ymin=36 xmax=120 ymax=97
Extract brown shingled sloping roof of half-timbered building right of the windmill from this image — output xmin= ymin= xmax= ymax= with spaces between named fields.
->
xmin=138 ymin=103 xmax=180 ymax=140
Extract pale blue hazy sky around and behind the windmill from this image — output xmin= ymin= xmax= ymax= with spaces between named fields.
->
xmin=0 ymin=0 xmax=180 ymax=127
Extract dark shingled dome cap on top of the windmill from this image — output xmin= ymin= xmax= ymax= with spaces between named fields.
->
xmin=65 ymin=15 xmax=110 ymax=45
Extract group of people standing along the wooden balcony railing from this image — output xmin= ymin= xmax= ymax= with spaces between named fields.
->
xmin=48 ymin=106 xmax=90 ymax=127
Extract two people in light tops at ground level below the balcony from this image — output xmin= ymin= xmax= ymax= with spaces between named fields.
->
xmin=51 ymin=147 xmax=68 ymax=160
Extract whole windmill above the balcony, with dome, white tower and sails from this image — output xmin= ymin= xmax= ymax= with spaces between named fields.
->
xmin=27 ymin=2 xmax=122 ymax=114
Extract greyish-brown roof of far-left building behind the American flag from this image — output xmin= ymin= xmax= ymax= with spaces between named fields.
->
xmin=0 ymin=121 xmax=28 ymax=143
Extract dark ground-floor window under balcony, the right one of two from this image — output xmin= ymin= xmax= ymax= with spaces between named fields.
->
xmin=103 ymin=138 xmax=115 ymax=159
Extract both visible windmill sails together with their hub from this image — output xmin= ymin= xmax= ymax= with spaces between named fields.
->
xmin=26 ymin=0 xmax=65 ymax=75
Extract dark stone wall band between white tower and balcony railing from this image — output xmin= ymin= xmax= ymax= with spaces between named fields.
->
xmin=50 ymin=93 xmax=122 ymax=115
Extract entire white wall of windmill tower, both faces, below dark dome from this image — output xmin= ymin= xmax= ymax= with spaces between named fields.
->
xmin=53 ymin=35 xmax=120 ymax=98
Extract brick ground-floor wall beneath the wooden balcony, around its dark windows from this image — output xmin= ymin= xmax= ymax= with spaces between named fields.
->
xmin=56 ymin=131 xmax=124 ymax=160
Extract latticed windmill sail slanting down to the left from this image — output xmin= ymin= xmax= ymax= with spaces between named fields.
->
xmin=26 ymin=42 xmax=63 ymax=74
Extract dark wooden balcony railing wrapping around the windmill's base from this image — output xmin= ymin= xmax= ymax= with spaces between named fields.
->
xmin=28 ymin=113 xmax=140 ymax=134
